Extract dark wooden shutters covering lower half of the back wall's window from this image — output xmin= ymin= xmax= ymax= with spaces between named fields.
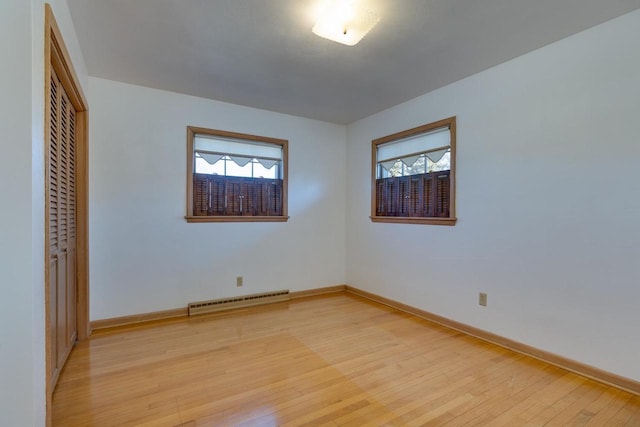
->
xmin=193 ymin=173 xmax=283 ymax=216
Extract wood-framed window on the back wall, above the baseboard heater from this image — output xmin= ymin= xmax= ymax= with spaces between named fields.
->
xmin=186 ymin=127 xmax=288 ymax=222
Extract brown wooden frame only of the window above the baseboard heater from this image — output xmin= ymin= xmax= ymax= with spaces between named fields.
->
xmin=185 ymin=126 xmax=289 ymax=223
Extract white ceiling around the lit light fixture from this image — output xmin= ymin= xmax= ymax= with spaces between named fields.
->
xmin=67 ymin=0 xmax=640 ymax=123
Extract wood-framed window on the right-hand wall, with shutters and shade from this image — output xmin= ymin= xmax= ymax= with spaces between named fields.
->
xmin=371 ymin=117 xmax=456 ymax=225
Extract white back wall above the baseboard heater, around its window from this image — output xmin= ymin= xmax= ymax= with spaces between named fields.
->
xmin=89 ymin=78 xmax=345 ymax=319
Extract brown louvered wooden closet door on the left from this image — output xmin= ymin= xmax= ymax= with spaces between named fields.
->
xmin=48 ymin=70 xmax=77 ymax=384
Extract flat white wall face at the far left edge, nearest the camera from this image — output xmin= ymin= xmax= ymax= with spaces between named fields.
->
xmin=0 ymin=0 xmax=34 ymax=426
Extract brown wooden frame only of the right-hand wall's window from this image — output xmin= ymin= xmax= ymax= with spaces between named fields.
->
xmin=370 ymin=116 xmax=457 ymax=226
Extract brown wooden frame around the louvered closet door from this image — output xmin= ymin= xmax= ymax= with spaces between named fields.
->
xmin=44 ymin=4 xmax=91 ymax=426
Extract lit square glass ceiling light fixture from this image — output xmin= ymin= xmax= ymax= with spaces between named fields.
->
xmin=312 ymin=0 xmax=380 ymax=46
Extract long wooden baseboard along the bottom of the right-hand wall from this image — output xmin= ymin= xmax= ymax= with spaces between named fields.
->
xmin=345 ymin=285 xmax=640 ymax=395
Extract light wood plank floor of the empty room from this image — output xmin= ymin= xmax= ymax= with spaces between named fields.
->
xmin=53 ymin=293 xmax=640 ymax=427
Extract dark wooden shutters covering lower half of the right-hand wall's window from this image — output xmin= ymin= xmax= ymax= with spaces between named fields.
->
xmin=376 ymin=171 xmax=451 ymax=218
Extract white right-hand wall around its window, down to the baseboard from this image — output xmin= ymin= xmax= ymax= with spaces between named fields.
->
xmin=346 ymin=11 xmax=640 ymax=380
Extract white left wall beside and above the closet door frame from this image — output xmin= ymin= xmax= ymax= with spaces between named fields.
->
xmin=0 ymin=0 xmax=86 ymax=426
